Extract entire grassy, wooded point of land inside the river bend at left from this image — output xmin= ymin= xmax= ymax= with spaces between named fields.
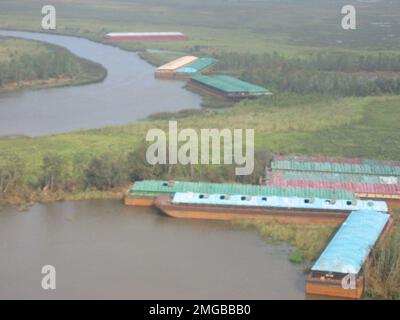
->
xmin=0 ymin=38 xmax=107 ymax=91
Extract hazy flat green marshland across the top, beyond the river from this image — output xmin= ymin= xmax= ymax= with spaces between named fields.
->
xmin=0 ymin=0 xmax=400 ymax=54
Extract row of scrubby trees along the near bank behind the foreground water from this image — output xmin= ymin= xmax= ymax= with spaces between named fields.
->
xmin=0 ymin=144 xmax=270 ymax=197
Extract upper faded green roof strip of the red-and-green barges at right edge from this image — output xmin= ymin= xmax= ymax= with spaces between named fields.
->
xmin=271 ymin=160 xmax=400 ymax=176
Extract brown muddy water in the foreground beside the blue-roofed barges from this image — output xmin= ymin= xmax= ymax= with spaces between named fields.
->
xmin=0 ymin=200 xmax=305 ymax=299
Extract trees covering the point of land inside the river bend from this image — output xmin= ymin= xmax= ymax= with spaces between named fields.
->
xmin=0 ymin=44 xmax=106 ymax=86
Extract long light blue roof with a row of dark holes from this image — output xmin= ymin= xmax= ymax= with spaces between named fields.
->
xmin=172 ymin=192 xmax=388 ymax=212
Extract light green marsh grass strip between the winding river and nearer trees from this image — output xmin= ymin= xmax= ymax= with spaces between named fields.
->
xmin=0 ymin=95 xmax=400 ymax=195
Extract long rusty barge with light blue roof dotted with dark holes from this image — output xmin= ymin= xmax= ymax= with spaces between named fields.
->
xmin=154 ymin=192 xmax=388 ymax=223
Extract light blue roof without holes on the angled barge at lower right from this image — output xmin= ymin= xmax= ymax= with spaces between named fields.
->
xmin=312 ymin=211 xmax=389 ymax=274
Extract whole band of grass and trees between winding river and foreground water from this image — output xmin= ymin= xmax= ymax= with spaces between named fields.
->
xmin=0 ymin=94 xmax=400 ymax=205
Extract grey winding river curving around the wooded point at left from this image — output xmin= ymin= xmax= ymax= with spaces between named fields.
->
xmin=0 ymin=31 xmax=201 ymax=136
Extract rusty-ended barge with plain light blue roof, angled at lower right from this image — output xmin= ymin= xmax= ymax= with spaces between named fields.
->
xmin=306 ymin=211 xmax=393 ymax=299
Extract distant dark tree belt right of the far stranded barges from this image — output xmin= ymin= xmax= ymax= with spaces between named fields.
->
xmin=216 ymin=52 xmax=400 ymax=96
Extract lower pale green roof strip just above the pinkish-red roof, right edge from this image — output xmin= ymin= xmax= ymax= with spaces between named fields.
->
xmin=269 ymin=170 xmax=400 ymax=184
